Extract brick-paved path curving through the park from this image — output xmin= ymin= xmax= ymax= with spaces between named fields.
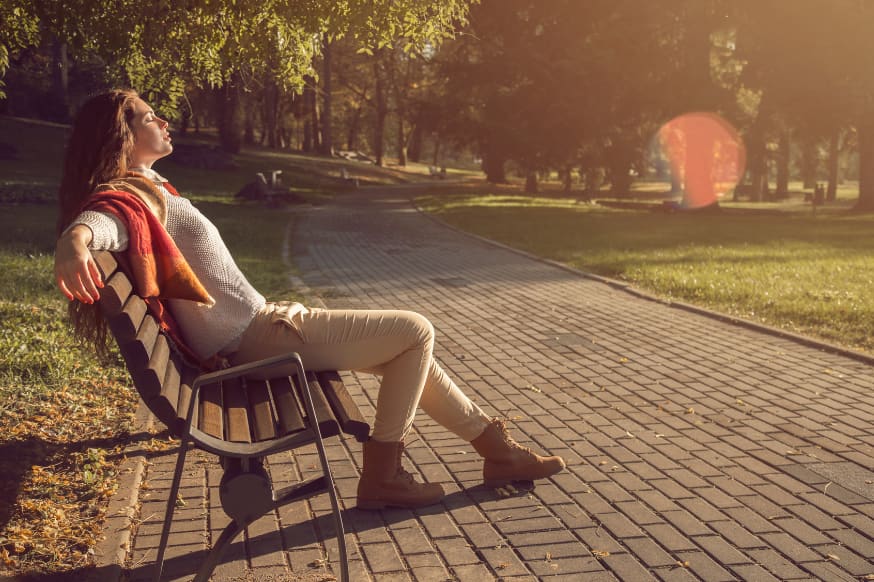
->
xmin=122 ymin=190 xmax=874 ymax=581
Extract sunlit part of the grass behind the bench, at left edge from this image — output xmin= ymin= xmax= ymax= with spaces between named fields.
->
xmin=0 ymin=248 xmax=136 ymax=571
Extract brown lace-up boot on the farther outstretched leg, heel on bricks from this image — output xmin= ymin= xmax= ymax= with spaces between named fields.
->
xmin=470 ymin=418 xmax=565 ymax=487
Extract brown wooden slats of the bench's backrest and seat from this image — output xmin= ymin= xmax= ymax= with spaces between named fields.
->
xmin=93 ymin=251 xmax=370 ymax=442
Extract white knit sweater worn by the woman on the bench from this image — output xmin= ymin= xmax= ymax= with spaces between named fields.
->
xmin=73 ymin=169 xmax=265 ymax=358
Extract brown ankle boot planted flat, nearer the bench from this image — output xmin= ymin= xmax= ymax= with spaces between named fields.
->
xmin=358 ymin=439 xmax=444 ymax=509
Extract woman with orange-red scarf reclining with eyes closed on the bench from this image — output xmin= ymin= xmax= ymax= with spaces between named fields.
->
xmin=55 ymin=90 xmax=565 ymax=509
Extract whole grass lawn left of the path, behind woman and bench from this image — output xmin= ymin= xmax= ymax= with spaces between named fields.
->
xmin=0 ymin=118 xmax=358 ymax=577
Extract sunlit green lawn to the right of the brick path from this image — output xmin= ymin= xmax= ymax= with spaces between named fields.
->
xmin=419 ymin=196 xmax=874 ymax=353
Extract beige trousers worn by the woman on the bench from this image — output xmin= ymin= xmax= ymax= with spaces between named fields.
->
xmin=228 ymin=302 xmax=490 ymax=442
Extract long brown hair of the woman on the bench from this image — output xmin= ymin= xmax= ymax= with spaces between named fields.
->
xmin=57 ymin=89 xmax=139 ymax=356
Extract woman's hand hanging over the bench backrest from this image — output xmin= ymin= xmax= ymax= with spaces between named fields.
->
xmin=55 ymin=224 xmax=103 ymax=303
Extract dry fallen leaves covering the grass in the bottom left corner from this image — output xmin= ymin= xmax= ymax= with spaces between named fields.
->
xmin=0 ymin=378 xmax=136 ymax=573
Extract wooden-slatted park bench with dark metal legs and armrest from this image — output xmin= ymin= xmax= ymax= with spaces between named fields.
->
xmin=94 ymin=251 xmax=370 ymax=582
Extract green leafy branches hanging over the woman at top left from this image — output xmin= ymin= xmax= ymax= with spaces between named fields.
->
xmin=0 ymin=0 xmax=467 ymax=116
